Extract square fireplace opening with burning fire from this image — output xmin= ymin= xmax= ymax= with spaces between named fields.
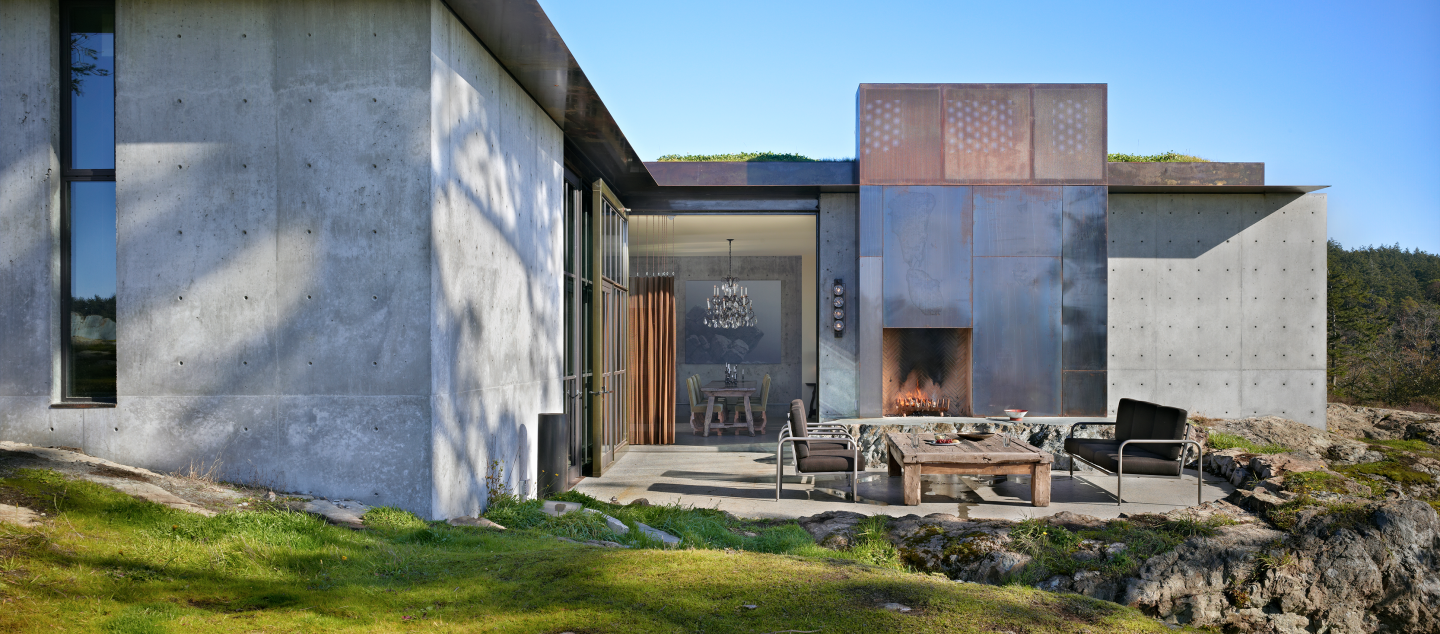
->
xmin=881 ymin=329 xmax=971 ymax=416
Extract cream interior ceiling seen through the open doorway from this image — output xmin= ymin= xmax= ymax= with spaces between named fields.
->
xmin=631 ymin=213 xmax=815 ymax=256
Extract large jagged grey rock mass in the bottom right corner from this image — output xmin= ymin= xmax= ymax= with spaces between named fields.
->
xmin=1122 ymin=500 xmax=1440 ymax=633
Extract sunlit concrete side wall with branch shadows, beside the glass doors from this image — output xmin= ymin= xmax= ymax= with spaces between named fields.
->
xmin=429 ymin=0 xmax=564 ymax=517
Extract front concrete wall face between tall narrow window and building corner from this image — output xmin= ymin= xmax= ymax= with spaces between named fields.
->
xmin=112 ymin=0 xmax=431 ymax=512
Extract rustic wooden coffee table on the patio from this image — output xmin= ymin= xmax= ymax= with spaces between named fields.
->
xmin=886 ymin=432 xmax=1054 ymax=506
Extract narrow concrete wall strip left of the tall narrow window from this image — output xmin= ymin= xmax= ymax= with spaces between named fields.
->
xmin=0 ymin=0 xmax=61 ymax=447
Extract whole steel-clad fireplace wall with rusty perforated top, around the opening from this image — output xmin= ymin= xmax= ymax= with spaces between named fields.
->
xmin=854 ymin=85 xmax=1109 ymax=416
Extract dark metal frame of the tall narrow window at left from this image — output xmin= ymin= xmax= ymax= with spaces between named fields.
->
xmin=56 ymin=0 xmax=120 ymax=406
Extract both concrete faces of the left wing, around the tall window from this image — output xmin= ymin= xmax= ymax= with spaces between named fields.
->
xmin=0 ymin=0 xmax=563 ymax=517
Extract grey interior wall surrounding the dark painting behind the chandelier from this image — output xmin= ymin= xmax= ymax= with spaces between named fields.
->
xmin=675 ymin=255 xmax=809 ymax=417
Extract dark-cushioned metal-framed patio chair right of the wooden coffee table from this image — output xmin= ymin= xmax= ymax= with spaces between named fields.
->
xmin=1066 ymin=399 xmax=1205 ymax=506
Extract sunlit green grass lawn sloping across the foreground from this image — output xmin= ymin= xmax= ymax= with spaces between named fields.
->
xmin=0 ymin=470 xmax=1186 ymax=634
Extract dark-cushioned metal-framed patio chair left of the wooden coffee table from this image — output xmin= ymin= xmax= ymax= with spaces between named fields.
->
xmin=775 ymin=399 xmax=865 ymax=501
